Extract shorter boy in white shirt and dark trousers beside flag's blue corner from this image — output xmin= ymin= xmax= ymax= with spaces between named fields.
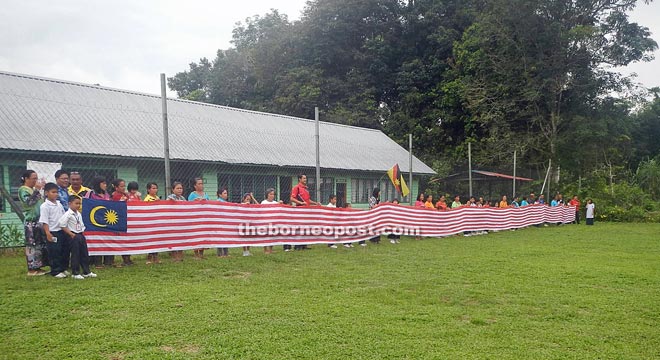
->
xmin=60 ymin=195 xmax=96 ymax=280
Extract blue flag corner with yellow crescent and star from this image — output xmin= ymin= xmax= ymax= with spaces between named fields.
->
xmin=82 ymin=199 xmax=127 ymax=232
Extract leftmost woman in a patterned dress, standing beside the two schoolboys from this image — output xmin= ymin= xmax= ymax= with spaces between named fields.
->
xmin=18 ymin=170 xmax=47 ymax=276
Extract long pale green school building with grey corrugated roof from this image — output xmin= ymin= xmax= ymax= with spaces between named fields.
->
xmin=0 ymin=72 xmax=435 ymax=223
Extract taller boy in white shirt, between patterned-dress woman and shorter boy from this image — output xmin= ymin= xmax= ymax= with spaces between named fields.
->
xmin=39 ymin=183 xmax=67 ymax=279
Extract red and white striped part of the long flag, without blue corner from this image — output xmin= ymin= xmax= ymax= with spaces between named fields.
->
xmin=85 ymin=201 xmax=575 ymax=255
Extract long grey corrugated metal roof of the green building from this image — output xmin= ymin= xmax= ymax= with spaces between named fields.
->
xmin=0 ymin=72 xmax=434 ymax=174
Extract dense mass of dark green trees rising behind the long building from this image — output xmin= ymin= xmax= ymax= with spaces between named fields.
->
xmin=168 ymin=0 xmax=660 ymax=219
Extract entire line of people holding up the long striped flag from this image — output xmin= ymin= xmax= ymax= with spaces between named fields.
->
xmin=18 ymin=170 xmax=595 ymax=279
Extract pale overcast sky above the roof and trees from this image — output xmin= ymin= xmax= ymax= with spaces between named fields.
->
xmin=0 ymin=0 xmax=660 ymax=95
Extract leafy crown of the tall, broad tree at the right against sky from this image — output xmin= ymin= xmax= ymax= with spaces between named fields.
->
xmin=454 ymin=0 xmax=657 ymax=167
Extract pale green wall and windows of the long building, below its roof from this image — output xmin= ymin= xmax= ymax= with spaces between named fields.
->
xmin=0 ymin=152 xmax=418 ymax=247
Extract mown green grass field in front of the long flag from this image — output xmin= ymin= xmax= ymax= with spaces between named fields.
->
xmin=0 ymin=223 xmax=660 ymax=359
